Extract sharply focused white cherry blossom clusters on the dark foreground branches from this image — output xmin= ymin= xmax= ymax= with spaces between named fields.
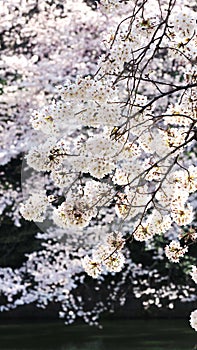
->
xmin=20 ymin=2 xmax=197 ymax=276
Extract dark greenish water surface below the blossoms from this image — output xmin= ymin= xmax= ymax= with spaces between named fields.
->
xmin=0 ymin=319 xmax=197 ymax=350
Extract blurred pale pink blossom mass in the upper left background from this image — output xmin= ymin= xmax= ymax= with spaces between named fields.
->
xmin=0 ymin=0 xmax=123 ymax=165
